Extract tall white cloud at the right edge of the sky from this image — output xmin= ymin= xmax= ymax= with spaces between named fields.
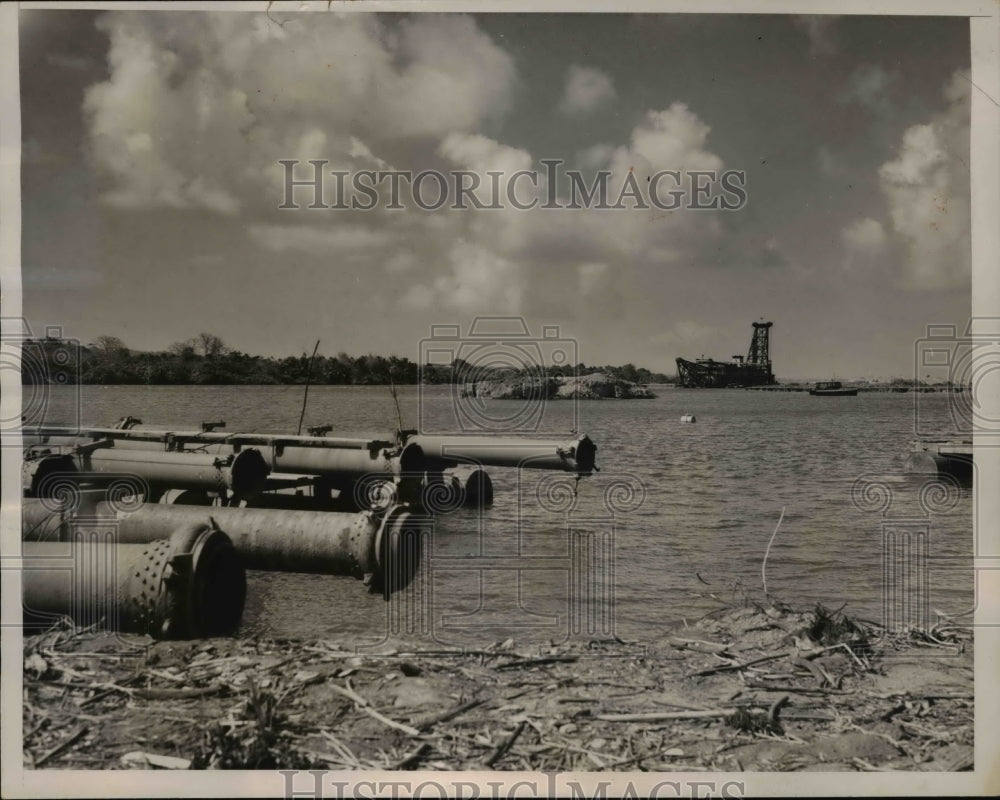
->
xmin=878 ymin=72 xmax=971 ymax=289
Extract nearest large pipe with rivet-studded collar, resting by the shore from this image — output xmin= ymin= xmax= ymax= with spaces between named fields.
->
xmin=21 ymin=522 xmax=246 ymax=639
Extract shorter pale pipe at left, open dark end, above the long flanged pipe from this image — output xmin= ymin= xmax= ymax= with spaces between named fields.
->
xmin=73 ymin=447 xmax=269 ymax=497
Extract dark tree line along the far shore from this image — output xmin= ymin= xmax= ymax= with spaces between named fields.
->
xmin=21 ymin=333 xmax=673 ymax=386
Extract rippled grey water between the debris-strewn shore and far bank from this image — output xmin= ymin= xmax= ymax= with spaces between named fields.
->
xmin=29 ymin=386 xmax=974 ymax=645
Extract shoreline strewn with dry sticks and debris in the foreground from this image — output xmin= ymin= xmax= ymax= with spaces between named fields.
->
xmin=23 ymin=600 xmax=975 ymax=772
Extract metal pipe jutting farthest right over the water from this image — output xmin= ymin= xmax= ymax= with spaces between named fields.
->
xmin=399 ymin=435 xmax=597 ymax=475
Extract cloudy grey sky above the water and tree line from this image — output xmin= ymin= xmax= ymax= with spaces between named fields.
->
xmin=20 ymin=10 xmax=971 ymax=380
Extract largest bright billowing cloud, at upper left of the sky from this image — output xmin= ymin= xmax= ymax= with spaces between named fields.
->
xmin=84 ymin=12 xmax=515 ymax=215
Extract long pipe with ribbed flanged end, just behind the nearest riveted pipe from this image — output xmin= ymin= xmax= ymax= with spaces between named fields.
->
xmin=21 ymin=500 xmax=425 ymax=592
